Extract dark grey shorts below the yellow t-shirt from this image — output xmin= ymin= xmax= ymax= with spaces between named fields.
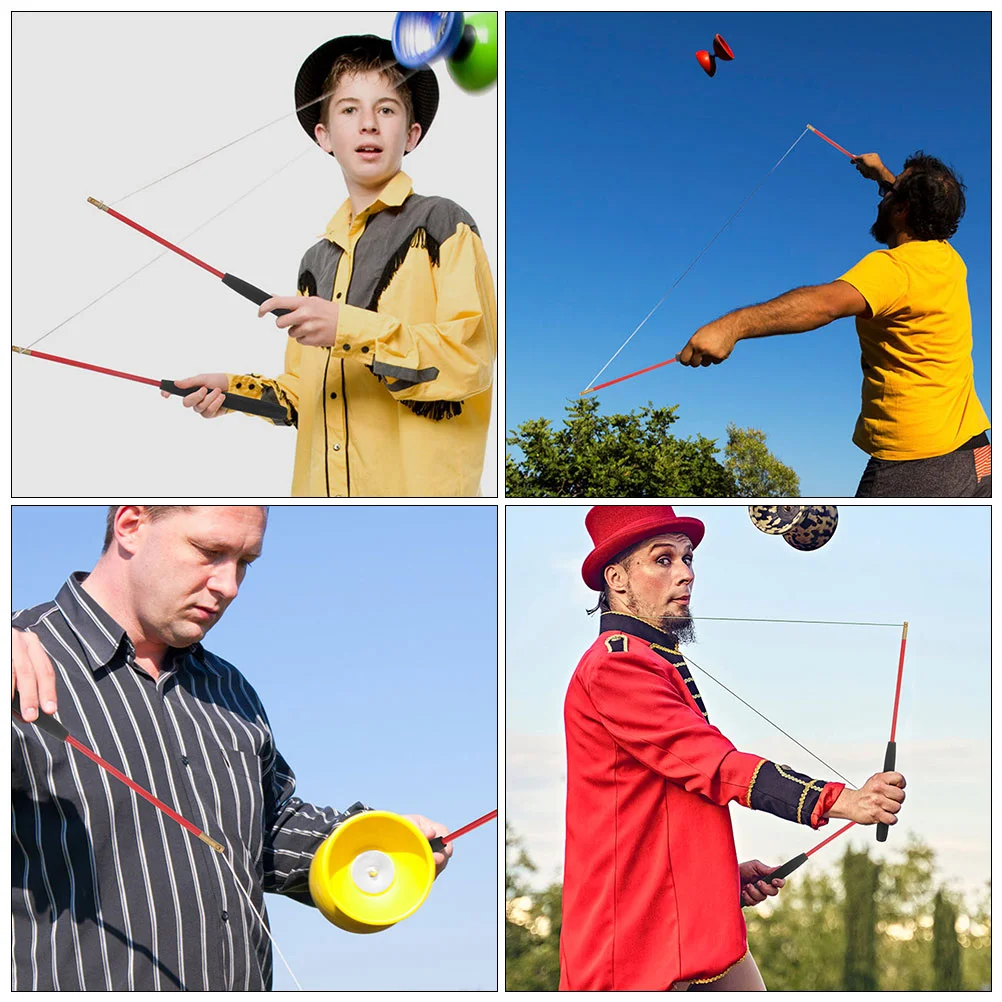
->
xmin=856 ymin=432 xmax=992 ymax=498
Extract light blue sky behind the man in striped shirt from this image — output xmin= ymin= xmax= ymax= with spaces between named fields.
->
xmin=12 ymin=506 xmax=499 ymax=990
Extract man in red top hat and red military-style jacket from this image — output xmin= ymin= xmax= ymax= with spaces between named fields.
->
xmin=560 ymin=505 xmax=905 ymax=991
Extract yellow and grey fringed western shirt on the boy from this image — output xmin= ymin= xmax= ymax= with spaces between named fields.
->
xmin=228 ymin=172 xmax=497 ymax=497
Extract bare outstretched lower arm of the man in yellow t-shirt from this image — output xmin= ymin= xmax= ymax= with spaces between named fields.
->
xmin=678 ymin=280 xmax=870 ymax=366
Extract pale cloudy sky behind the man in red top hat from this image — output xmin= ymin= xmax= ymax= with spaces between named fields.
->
xmin=505 ymin=504 xmax=991 ymax=894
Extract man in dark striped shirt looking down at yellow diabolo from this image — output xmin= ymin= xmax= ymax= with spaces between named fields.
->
xmin=11 ymin=505 xmax=451 ymax=991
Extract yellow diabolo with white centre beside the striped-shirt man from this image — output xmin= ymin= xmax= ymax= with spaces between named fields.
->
xmin=310 ymin=811 xmax=435 ymax=933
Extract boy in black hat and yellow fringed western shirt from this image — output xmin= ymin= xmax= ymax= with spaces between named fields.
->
xmin=177 ymin=35 xmax=497 ymax=497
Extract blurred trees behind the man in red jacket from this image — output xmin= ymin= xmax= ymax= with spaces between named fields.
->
xmin=505 ymin=827 xmax=991 ymax=992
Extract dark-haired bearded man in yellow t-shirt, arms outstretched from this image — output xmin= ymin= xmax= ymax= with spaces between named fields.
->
xmin=678 ymin=151 xmax=991 ymax=497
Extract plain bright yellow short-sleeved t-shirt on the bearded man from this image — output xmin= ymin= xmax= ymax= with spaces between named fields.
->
xmin=841 ymin=240 xmax=991 ymax=460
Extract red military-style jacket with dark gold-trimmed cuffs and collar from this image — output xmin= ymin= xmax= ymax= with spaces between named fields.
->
xmin=560 ymin=612 xmax=844 ymax=991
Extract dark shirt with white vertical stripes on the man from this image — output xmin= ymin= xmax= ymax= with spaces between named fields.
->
xmin=11 ymin=573 xmax=361 ymax=991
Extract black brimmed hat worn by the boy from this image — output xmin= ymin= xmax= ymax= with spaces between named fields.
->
xmin=296 ymin=35 xmax=439 ymax=150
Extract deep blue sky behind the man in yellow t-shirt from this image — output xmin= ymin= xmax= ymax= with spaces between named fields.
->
xmin=506 ymin=13 xmax=991 ymax=497
